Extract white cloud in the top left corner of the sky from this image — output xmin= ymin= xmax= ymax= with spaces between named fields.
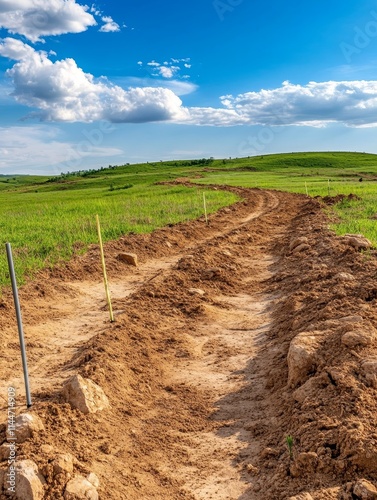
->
xmin=0 ymin=0 xmax=97 ymax=42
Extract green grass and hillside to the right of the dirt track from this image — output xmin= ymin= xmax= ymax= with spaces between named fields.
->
xmin=195 ymin=153 xmax=377 ymax=246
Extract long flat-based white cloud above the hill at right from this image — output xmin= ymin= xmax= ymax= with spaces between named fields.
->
xmin=182 ymin=80 xmax=377 ymax=127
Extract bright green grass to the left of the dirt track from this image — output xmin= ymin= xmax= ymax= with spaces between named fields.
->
xmin=0 ymin=179 xmax=237 ymax=285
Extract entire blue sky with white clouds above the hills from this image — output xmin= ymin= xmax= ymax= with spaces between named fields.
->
xmin=0 ymin=0 xmax=377 ymax=175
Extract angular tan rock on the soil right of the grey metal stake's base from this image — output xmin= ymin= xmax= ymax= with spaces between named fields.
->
xmin=63 ymin=375 xmax=110 ymax=413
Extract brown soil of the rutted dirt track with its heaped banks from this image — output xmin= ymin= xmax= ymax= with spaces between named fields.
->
xmin=0 ymin=187 xmax=377 ymax=500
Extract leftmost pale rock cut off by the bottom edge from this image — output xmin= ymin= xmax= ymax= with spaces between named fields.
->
xmin=16 ymin=460 xmax=45 ymax=500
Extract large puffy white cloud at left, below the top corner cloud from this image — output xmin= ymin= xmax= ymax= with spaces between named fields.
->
xmin=0 ymin=38 xmax=186 ymax=123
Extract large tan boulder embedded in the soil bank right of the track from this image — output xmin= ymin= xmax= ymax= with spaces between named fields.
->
xmin=287 ymin=331 xmax=325 ymax=388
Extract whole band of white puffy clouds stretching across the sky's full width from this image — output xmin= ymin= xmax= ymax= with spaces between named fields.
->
xmin=0 ymin=38 xmax=377 ymax=127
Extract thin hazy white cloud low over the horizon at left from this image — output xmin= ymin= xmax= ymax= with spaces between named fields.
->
xmin=0 ymin=125 xmax=124 ymax=175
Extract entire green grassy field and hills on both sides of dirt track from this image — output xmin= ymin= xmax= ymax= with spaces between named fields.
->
xmin=0 ymin=153 xmax=377 ymax=286
